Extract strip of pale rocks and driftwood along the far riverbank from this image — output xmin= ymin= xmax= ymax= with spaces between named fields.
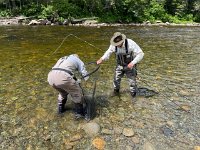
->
xmin=0 ymin=16 xmax=200 ymax=27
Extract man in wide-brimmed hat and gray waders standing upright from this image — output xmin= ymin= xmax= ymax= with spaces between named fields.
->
xmin=97 ymin=32 xmax=144 ymax=102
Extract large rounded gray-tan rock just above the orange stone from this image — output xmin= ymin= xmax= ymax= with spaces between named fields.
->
xmin=83 ymin=122 xmax=100 ymax=136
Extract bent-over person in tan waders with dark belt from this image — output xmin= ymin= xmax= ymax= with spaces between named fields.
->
xmin=48 ymin=54 xmax=89 ymax=119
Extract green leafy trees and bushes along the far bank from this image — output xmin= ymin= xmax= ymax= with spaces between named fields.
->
xmin=0 ymin=0 xmax=200 ymax=23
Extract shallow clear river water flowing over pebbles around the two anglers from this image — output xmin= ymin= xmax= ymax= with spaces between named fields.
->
xmin=0 ymin=26 xmax=200 ymax=150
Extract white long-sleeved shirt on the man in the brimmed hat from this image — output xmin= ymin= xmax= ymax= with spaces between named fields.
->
xmin=101 ymin=39 xmax=144 ymax=65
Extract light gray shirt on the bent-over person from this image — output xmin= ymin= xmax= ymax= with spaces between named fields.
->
xmin=53 ymin=54 xmax=87 ymax=76
